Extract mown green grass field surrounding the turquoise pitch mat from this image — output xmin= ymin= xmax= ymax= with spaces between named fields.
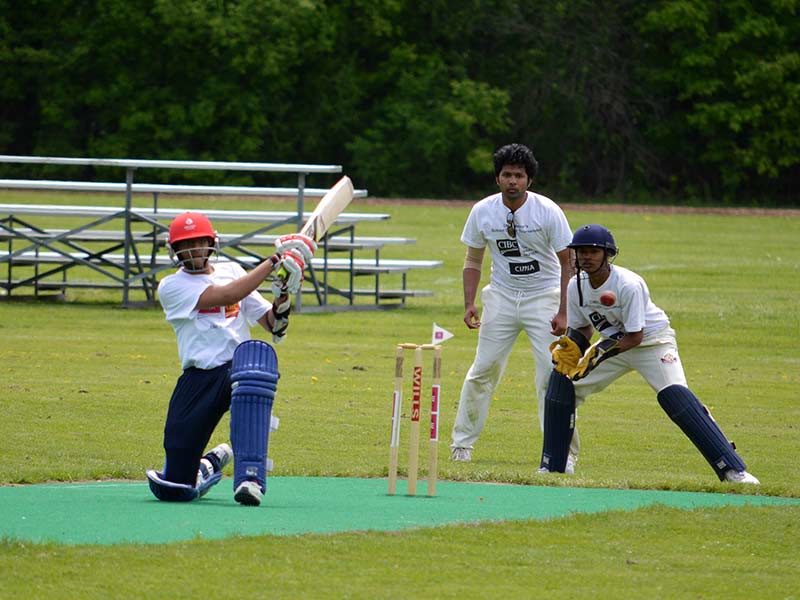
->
xmin=0 ymin=193 xmax=800 ymax=598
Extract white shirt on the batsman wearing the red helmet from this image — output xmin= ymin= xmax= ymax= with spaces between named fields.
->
xmin=158 ymin=261 xmax=272 ymax=369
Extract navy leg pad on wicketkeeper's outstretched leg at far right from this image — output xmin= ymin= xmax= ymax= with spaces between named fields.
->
xmin=658 ymin=385 xmax=745 ymax=481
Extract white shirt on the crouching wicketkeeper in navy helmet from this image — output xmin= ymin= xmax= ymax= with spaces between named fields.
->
xmin=567 ymin=265 xmax=669 ymax=346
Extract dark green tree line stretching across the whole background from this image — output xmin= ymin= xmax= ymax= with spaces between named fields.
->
xmin=0 ymin=0 xmax=800 ymax=204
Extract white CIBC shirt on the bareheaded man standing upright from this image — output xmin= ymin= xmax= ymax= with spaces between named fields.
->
xmin=461 ymin=192 xmax=572 ymax=292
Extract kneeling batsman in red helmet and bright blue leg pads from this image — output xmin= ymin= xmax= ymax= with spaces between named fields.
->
xmin=147 ymin=212 xmax=317 ymax=506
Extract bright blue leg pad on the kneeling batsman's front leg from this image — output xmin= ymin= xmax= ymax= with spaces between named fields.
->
xmin=231 ymin=340 xmax=280 ymax=493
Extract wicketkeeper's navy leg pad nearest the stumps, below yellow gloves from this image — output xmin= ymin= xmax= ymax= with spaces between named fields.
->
xmin=540 ymin=371 xmax=575 ymax=473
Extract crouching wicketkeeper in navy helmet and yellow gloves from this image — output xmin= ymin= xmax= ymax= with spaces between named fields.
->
xmin=539 ymin=225 xmax=759 ymax=484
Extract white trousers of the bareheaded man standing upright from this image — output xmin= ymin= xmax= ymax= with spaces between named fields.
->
xmin=451 ymin=285 xmax=580 ymax=454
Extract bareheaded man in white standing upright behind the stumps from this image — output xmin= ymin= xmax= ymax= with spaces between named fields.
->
xmin=451 ymin=144 xmax=578 ymax=462
